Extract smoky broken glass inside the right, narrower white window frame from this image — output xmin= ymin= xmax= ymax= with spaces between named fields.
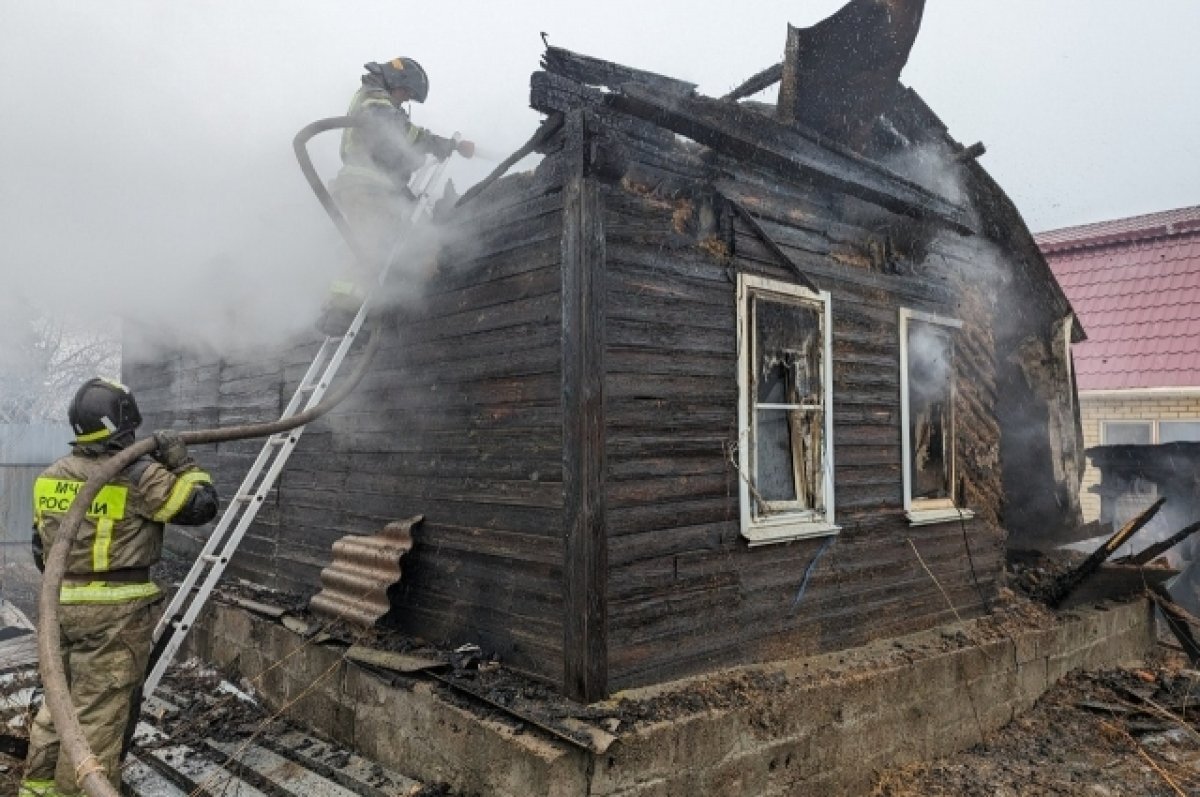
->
xmin=907 ymin=320 xmax=954 ymax=501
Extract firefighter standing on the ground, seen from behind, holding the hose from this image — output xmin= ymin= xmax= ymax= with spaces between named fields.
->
xmin=19 ymin=378 xmax=217 ymax=797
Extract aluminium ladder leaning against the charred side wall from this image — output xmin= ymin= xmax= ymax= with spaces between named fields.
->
xmin=142 ymin=153 xmax=457 ymax=700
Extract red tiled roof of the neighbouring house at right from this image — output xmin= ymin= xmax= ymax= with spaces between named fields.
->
xmin=1034 ymin=206 xmax=1200 ymax=390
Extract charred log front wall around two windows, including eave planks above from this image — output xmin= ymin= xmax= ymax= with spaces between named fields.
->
xmin=532 ymin=48 xmax=1003 ymax=690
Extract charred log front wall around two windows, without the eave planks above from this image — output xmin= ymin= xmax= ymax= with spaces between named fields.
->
xmin=605 ymin=162 xmax=1003 ymax=688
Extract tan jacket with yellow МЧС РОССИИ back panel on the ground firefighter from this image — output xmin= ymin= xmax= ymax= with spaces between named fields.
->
xmin=34 ymin=447 xmax=217 ymax=604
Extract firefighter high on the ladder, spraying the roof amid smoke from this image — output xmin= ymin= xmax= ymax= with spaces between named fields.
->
xmin=318 ymin=58 xmax=475 ymax=335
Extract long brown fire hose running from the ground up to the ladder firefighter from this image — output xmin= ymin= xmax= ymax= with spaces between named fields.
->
xmin=37 ymin=116 xmax=380 ymax=797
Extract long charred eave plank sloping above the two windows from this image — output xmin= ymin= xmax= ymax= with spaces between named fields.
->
xmin=604 ymin=85 xmax=974 ymax=234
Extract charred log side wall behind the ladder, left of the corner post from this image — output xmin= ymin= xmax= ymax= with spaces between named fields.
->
xmin=127 ymin=166 xmax=563 ymax=682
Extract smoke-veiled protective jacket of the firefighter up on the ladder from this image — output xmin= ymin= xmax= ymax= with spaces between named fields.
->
xmin=338 ymin=76 xmax=455 ymax=193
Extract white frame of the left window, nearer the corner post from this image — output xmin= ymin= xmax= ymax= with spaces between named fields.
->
xmin=738 ymin=274 xmax=841 ymax=547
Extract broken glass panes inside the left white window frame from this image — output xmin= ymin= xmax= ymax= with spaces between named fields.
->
xmin=751 ymin=296 xmax=824 ymax=514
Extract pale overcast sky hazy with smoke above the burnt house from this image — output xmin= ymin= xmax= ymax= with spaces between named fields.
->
xmin=0 ymin=0 xmax=1200 ymax=355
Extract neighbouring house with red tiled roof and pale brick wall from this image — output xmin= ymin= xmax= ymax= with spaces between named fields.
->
xmin=1036 ymin=206 xmax=1200 ymax=521
